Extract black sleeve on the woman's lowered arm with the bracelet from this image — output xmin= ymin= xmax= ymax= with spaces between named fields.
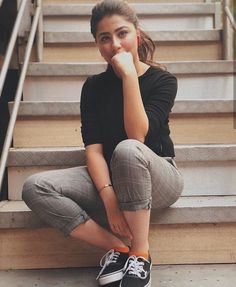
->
xmin=80 ymin=77 xmax=102 ymax=146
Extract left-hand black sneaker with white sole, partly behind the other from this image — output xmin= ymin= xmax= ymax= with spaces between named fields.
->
xmin=97 ymin=249 xmax=129 ymax=286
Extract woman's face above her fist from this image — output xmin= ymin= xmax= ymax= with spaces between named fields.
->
xmin=96 ymin=15 xmax=139 ymax=64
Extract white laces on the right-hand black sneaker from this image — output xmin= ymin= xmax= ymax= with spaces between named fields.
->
xmin=124 ymin=256 xmax=148 ymax=279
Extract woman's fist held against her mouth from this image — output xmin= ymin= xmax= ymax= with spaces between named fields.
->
xmin=111 ymin=52 xmax=137 ymax=78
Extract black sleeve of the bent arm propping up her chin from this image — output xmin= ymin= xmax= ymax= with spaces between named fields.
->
xmin=144 ymin=71 xmax=177 ymax=145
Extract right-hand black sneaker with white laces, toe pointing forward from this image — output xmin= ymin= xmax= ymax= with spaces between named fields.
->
xmin=120 ymin=256 xmax=152 ymax=287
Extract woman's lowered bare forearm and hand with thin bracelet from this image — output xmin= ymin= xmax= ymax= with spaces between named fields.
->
xmin=86 ymin=144 xmax=132 ymax=239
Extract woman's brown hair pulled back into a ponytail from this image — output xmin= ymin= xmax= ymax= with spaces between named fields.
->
xmin=90 ymin=0 xmax=163 ymax=68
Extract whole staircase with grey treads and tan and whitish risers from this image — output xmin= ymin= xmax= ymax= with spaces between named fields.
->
xmin=0 ymin=0 xmax=236 ymax=269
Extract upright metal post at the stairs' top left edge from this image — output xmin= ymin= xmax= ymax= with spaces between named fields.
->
xmin=36 ymin=0 xmax=43 ymax=62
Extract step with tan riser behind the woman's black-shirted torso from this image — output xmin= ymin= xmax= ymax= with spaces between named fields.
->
xmin=10 ymin=99 xmax=236 ymax=148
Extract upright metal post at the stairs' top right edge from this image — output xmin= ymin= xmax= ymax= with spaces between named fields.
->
xmin=223 ymin=0 xmax=234 ymax=60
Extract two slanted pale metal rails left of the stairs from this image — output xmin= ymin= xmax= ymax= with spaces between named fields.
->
xmin=0 ymin=0 xmax=42 ymax=195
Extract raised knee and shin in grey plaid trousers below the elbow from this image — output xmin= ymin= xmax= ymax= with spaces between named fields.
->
xmin=111 ymin=140 xmax=151 ymax=204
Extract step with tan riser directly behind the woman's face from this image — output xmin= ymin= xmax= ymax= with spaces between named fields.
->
xmin=19 ymin=29 xmax=223 ymax=62
